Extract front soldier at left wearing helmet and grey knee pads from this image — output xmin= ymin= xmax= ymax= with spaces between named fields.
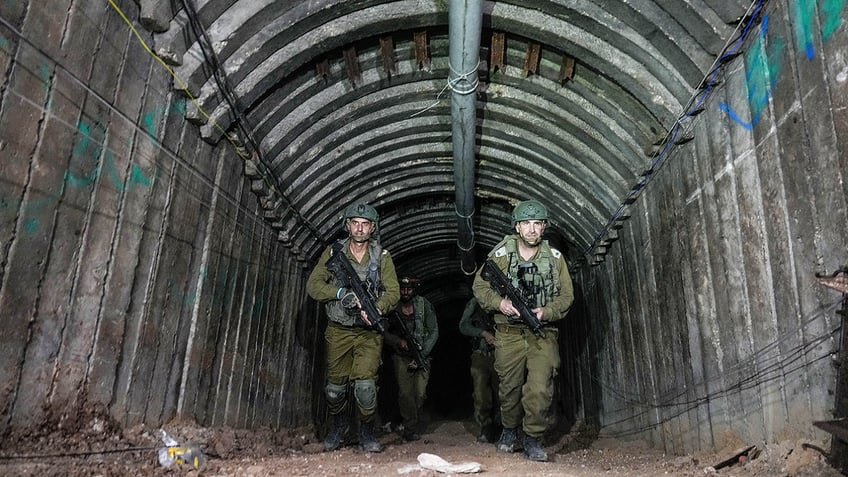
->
xmin=306 ymin=204 xmax=400 ymax=452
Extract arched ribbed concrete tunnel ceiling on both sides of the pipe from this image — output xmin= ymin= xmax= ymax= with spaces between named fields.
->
xmin=149 ymin=0 xmax=750 ymax=304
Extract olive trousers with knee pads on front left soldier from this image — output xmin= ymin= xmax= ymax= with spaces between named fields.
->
xmin=324 ymin=321 xmax=383 ymax=422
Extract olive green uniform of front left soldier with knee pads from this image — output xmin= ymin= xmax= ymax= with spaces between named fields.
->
xmin=306 ymin=239 xmax=400 ymax=422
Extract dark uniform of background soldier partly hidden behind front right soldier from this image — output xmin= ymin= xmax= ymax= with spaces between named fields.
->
xmin=459 ymin=297 xmax=500 ymax=432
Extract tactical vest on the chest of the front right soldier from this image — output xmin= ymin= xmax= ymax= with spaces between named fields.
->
xmin=490 ymin=235 xmax=562 ymax=308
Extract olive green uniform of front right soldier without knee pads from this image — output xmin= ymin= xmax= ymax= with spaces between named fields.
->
xmin=473 ymin=235 xmax=574 ymax=438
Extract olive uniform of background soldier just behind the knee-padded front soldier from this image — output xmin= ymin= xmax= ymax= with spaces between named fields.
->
xmin=386 ymin=295 xmax=439 ymax=432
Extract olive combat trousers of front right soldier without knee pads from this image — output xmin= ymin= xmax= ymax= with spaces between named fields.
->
xmin=495 ymin=324 xmax=560 ymax=438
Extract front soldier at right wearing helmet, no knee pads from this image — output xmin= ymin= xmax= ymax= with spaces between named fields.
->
xmin=473 ymin=200 xmax=574 ymax=461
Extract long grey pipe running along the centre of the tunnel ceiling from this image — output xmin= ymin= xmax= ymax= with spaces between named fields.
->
xmin=448 ymin=0 xmax=483 ymax=275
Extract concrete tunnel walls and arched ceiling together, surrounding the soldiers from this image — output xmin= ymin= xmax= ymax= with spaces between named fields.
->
xmin=0 ymin=0 xmax=848 ymax=469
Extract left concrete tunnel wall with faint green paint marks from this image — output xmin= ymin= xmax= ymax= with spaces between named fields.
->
xmin=0 ymin=2 xmax=320 ymax=431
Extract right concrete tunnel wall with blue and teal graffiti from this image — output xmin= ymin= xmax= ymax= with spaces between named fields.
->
xmin=564 ymin=2 xmax=848 ymax=453
